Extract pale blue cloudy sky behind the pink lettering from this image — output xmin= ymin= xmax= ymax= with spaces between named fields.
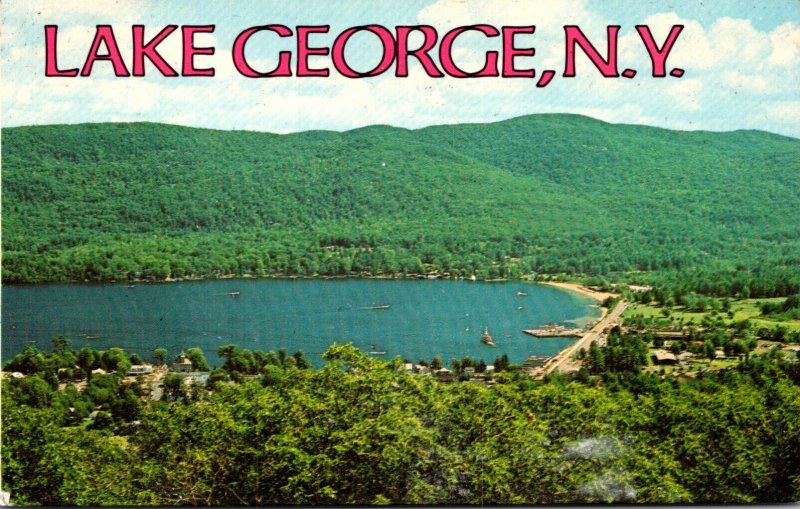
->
xmin=0 ymin=0 xmax=800 ymax=138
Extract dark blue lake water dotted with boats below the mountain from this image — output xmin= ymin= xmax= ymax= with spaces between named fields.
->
xmin=2 ymin=279 xmax=600 ymax=366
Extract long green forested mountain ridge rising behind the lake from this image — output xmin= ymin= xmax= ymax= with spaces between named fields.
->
xmin=2 ymin=115 xmax=800 ymax=293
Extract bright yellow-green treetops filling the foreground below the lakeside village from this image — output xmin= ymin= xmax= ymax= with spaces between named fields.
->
xmin=2 ymin=345 xmax=800 ymax=505
